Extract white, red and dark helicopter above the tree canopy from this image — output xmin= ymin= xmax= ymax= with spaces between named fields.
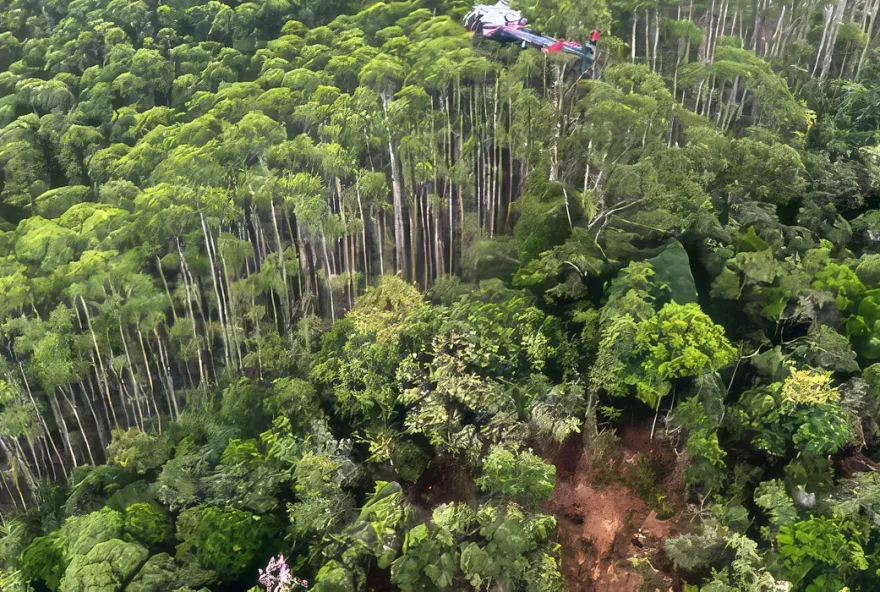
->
xmin=462 ymin=0 xmax=599 ymax=73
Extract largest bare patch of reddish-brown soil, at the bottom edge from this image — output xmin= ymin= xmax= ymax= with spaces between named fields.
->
xmin=546 ymin=422 xmax=686 ymax=592
